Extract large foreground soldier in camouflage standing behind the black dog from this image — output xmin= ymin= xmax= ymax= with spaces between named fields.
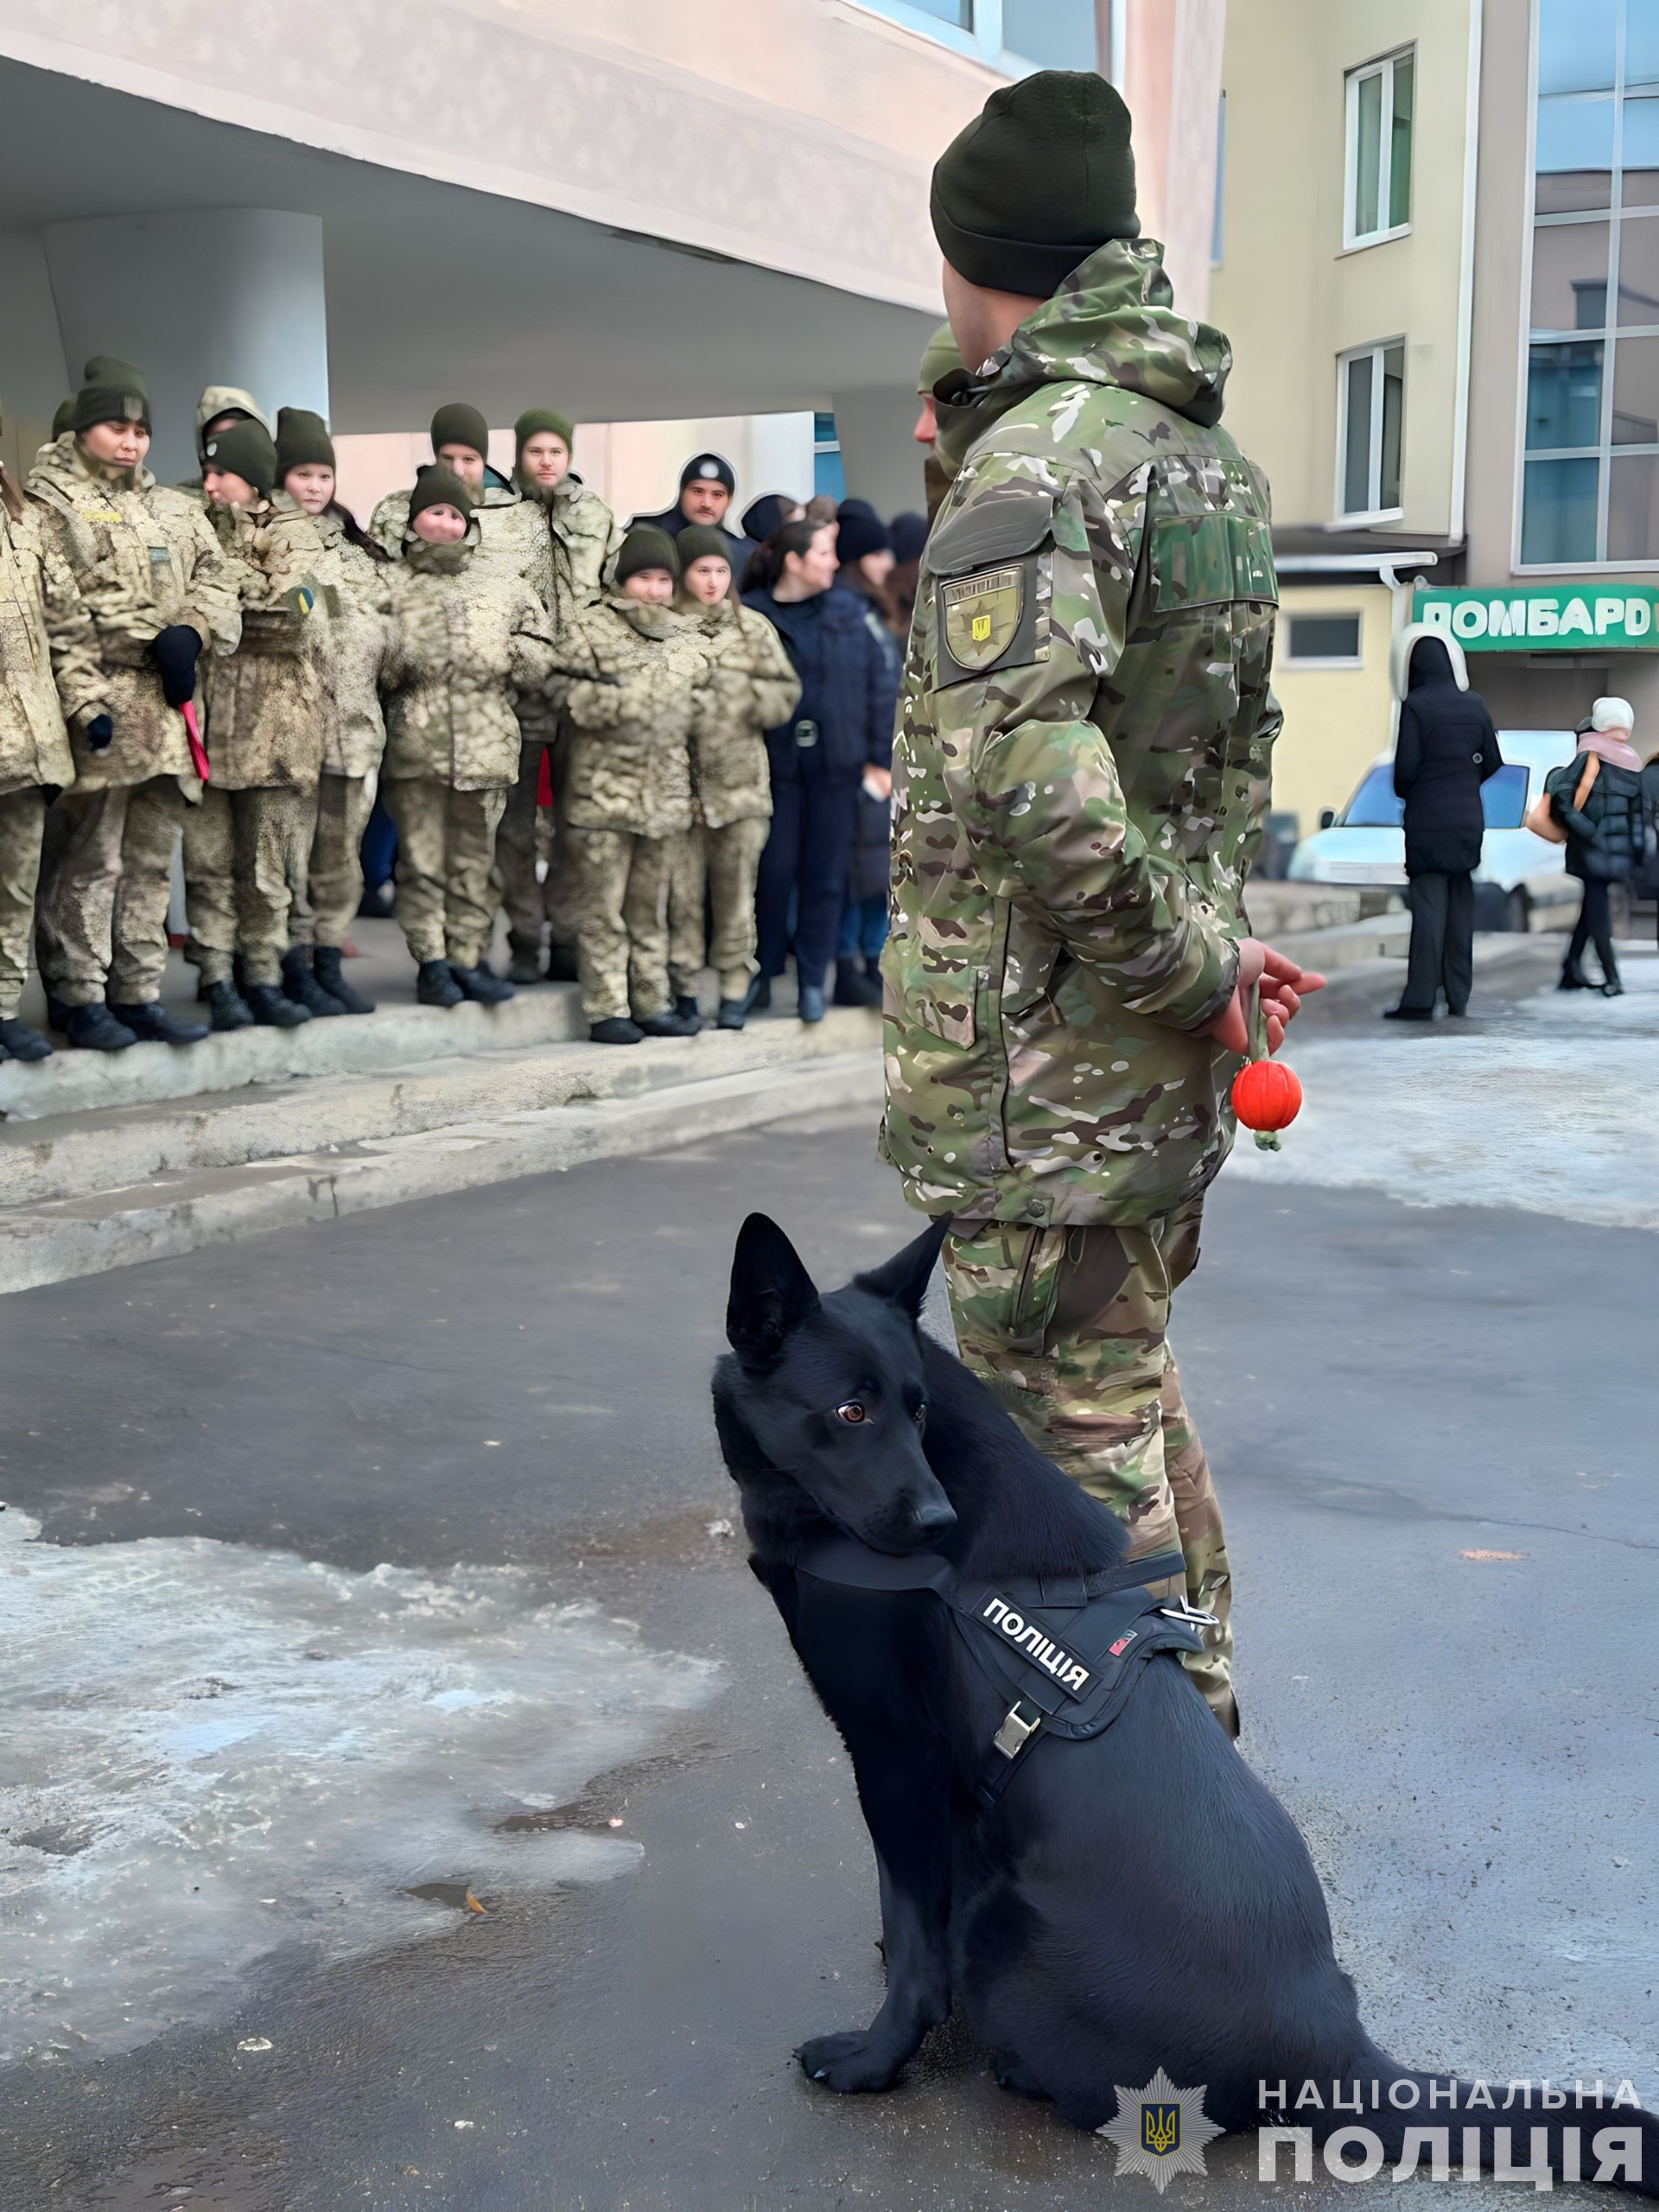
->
xmin=882 ymin=71 xmax=1327 ymax=1732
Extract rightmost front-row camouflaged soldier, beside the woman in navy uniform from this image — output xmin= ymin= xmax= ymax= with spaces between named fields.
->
xmin=668 ymin=524 xmax=801 ymax=1028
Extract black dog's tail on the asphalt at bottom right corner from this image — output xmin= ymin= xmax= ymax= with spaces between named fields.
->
xmin=1261 ymin=2050 xmax=1659 ymax=2196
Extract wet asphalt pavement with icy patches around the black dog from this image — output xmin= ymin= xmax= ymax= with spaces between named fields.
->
xmin=0 ymin=969 xmax=1659 ymax=2212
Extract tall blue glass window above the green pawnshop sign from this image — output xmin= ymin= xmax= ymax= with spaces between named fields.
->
xmin=1520 ymin=0 xmax=1659 ymax=569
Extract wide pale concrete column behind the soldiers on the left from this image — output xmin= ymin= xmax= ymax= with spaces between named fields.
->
xmin=44 ymin=208 xmax=327 ymax=485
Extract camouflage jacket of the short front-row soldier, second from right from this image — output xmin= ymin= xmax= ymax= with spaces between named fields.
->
xmin=553 ymin=593 xmax=708 ymax=836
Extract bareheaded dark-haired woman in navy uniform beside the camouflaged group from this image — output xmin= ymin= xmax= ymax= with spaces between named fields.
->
xmin=743 ymin=518 xmax=898 ymax=1022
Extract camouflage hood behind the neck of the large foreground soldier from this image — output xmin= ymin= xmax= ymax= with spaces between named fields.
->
xmin=938 ymin=238 xmax=1232 ymax=471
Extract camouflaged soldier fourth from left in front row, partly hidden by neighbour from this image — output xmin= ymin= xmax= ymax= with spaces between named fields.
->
xmin=276 ymin=407 xmax=391 ymax=1013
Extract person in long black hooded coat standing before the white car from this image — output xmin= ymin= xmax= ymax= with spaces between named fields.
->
xmin=1387 ymin=632 xmax=1504 ymax=1022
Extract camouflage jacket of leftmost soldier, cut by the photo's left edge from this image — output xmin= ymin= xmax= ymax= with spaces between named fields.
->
xmin=0 ymin=491 xmax=79 ymax=797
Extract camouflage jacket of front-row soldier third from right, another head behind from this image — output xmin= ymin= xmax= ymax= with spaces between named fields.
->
xmin=380 ymin=515 xmax=553 ymax=791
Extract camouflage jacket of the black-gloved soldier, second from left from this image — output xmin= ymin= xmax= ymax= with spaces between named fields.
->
xmin=29 ymin=431 xmax=241 ymax=798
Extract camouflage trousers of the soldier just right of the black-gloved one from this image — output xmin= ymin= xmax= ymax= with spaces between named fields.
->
xmin=183 ymin=783 xmax=316 ymax=984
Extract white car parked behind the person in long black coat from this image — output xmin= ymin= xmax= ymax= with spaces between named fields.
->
xmin=1289 ymin=730 xmax=1580 ymax=929
